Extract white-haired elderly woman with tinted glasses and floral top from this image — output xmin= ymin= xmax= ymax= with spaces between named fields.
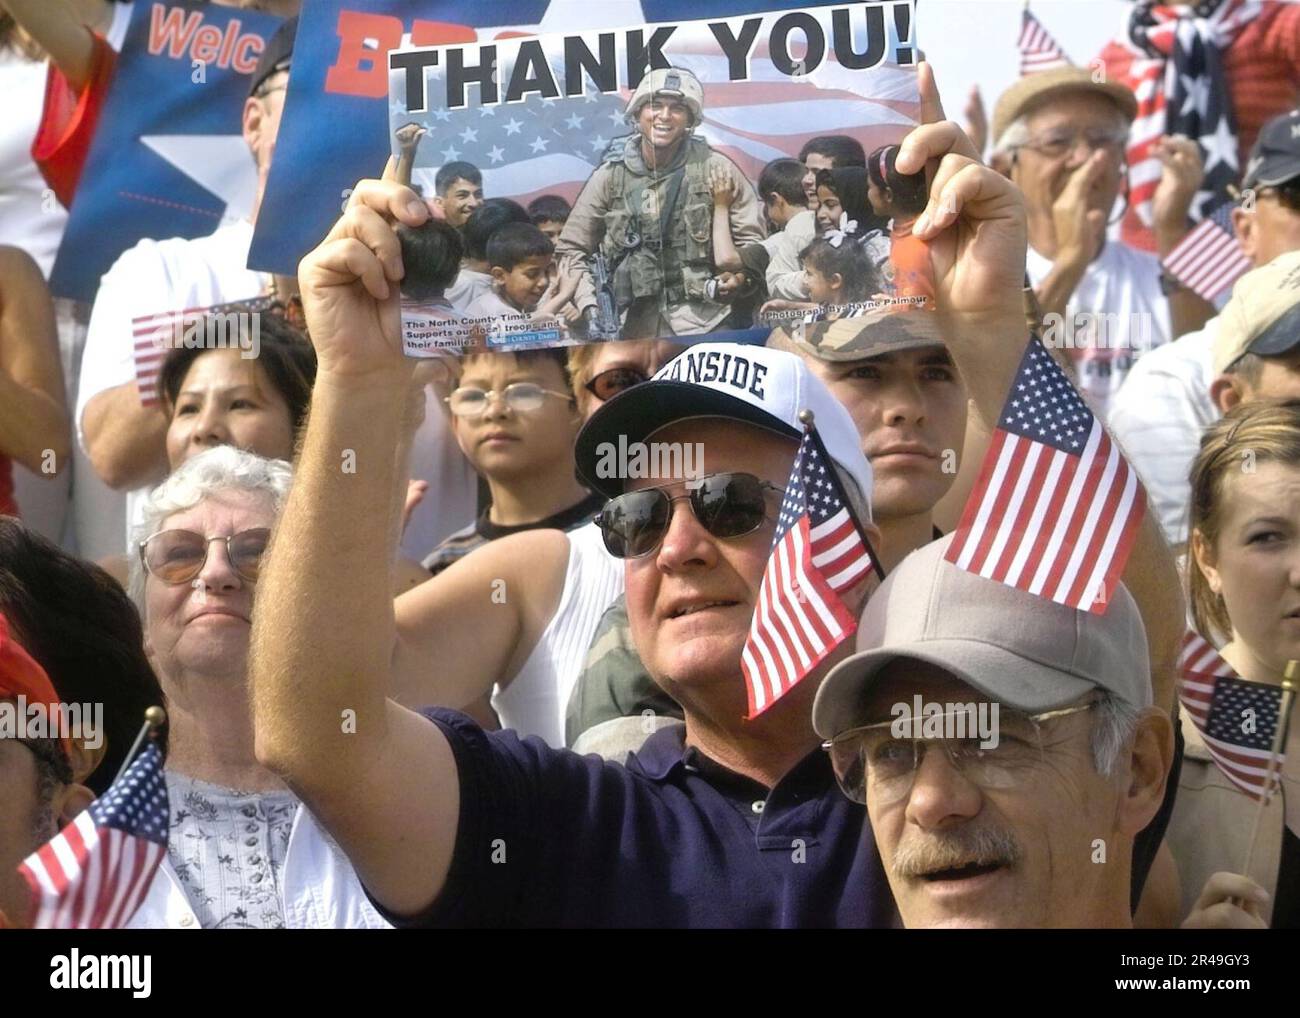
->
xmin=124 ymin=446 xmax=386 ymax=928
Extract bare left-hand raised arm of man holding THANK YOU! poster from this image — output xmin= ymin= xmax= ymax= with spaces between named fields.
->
xmin=250 ymin=181 xmax=460 ymax=914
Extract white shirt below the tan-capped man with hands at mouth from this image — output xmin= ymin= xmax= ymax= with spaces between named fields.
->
xmin=1110 ymin=317 xmax=1219 ymax=545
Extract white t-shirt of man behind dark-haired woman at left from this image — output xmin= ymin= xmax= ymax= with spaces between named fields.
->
xmin=74 ymin=220 xmax=269 ymax=542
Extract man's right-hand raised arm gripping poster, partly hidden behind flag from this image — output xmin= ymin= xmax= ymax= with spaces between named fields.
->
xmin=898 ymin=65 xmax=1184 ymax=710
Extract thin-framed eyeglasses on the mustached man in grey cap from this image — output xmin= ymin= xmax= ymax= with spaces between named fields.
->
xmin=822 ymin=701 xmax=1097 ymax=807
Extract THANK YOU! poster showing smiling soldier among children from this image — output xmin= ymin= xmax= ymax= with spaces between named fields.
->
xmin=389 ymin=0 xmax=933 ymax=355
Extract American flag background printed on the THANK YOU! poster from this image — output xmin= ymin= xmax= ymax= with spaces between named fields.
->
xmin=389 ymin=8 xmax=920 ymax=203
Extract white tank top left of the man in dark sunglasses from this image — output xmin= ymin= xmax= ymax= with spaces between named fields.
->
xmin=491 ymin=523 xmax=623 ymax=749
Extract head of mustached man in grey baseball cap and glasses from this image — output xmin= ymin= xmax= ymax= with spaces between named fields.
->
xmin=813 ymin=538 xmax=1173 ymax=927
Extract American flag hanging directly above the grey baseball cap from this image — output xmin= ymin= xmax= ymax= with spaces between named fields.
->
xmin=944 ymin=338 xmax=1147 ymax=615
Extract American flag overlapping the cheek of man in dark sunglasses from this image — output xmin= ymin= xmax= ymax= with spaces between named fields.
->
xmin=741 ymin=428 xmax=874 ymax=718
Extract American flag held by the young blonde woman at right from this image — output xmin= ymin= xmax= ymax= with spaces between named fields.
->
xmin=1178 ymin=632 xmax=1283 ymax=800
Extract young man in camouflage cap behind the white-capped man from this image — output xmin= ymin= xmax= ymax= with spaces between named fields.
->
xmin=767 ymin=309 xmax=967 ymax=571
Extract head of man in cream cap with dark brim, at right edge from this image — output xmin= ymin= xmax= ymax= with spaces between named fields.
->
xmin=1210 ymin=251 xmax=1300 ymax=413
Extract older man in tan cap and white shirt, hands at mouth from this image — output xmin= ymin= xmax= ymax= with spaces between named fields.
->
xmin=993 ymin=68 xmax=1213 ymax=417
